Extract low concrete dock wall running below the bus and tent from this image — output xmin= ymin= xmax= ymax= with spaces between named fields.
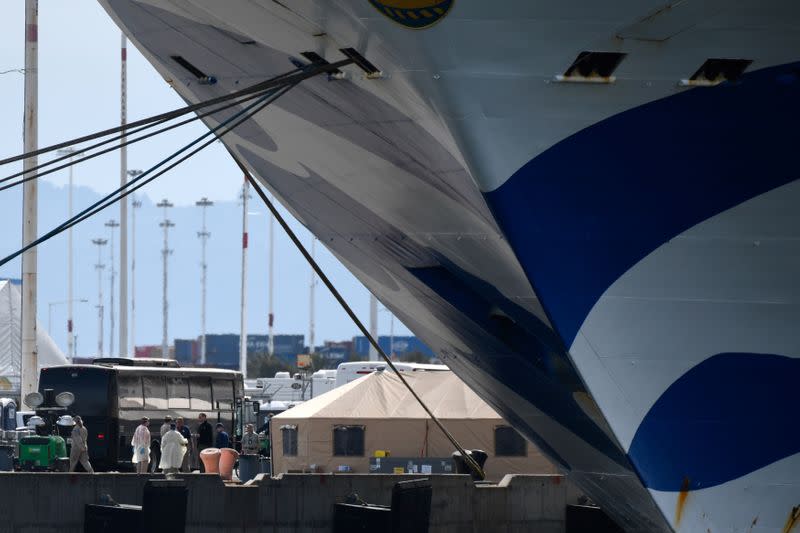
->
xmin=0 ymin=473 xmax=579 ymax=533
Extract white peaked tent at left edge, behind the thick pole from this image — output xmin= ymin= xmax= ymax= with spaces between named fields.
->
xmin=0 ymin=279 xmax=67 ymax=391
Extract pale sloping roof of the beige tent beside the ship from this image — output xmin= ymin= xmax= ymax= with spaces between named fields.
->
xmin=275 ymin=370 xmax=500 ymax=421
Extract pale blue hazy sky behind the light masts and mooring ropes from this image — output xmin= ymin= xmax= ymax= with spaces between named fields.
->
xmin=0 ymin=0 xmax=408 ymax=354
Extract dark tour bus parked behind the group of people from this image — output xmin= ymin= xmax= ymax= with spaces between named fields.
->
xmin=39 ymin=358 xmax=244 ymax=470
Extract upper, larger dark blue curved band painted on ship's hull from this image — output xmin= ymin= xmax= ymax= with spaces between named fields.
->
xmin=485 ymin=63 xmax=800 ymax=346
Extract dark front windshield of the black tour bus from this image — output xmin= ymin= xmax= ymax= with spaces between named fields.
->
xmin=39 ymin=366 xmax=111 ymax=417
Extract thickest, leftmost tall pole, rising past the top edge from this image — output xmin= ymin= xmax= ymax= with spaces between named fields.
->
xmin=20 ymin=0 xmax=39 ymax=398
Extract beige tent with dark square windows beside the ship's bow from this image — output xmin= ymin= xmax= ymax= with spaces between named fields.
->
xmin=271 ymin=371 xmax=555 ymax=480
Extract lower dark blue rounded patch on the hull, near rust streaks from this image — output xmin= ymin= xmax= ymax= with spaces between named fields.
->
xmin=628 ymin=353 xmax=800 ymax=492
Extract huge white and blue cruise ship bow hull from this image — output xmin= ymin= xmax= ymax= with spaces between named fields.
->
xmin=101 ymin=0 xmax=800 ymax=532
